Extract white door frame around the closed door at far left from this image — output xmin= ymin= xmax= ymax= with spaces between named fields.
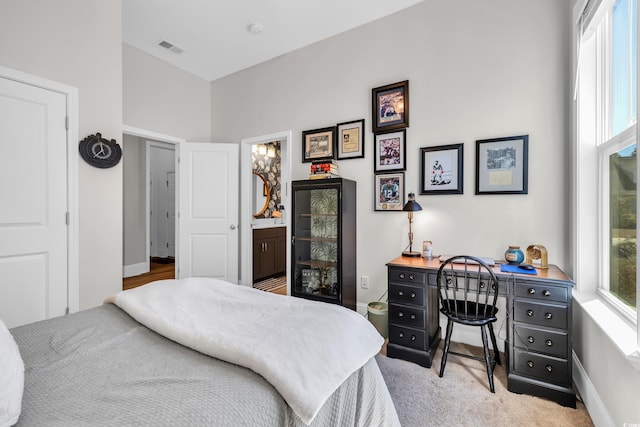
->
xmin=0 ymin=65 xmax=79 ymax=313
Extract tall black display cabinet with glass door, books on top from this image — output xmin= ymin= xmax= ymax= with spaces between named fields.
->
xmin=291 ymin=178 xmax=356 ymax=310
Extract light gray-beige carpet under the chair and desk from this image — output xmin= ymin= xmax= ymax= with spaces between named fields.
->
xmin=376 ymin=343 xmax=593 ymax=427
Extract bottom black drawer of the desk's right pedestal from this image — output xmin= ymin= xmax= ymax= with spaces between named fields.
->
xmin=513 ymin=349 xmax=571 ymax=387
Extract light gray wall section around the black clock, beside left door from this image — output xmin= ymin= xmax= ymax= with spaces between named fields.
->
xmin=0 ymin=0 xmax=122 ymax=308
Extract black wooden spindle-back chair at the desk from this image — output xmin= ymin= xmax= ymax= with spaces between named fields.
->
xmin=437 ymin=255 xmax=501 ymax=393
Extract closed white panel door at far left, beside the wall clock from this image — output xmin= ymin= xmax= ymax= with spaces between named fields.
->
xmin=0 ymin=78 xmax=68 ymax=327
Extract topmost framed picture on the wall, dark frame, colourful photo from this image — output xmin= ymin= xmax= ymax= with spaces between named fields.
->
xmin=371 ymin=80 xmax=409 ymax=133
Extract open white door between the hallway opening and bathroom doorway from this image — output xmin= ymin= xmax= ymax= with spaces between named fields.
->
xmin=177 ymin=142 xmax=239 ymax=283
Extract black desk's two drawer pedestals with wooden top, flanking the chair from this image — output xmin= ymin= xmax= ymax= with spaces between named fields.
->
xmin=387 ymin=257 xmax=576 ymax=408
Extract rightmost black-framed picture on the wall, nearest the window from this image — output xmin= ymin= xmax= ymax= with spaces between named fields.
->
xmin=476 ymin=135 xmax=529 ymax=194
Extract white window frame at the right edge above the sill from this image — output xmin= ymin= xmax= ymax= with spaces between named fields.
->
xmin=573 ymin=0 xmax=640 ymax=354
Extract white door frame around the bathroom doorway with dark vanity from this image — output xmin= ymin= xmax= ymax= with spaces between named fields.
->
xmin=239 ymin=130 xmax=293 ymax=294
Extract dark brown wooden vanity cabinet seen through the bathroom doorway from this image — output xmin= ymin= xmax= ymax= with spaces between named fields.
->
xmin=253 ymin=227 xmax=287 ymax=283
